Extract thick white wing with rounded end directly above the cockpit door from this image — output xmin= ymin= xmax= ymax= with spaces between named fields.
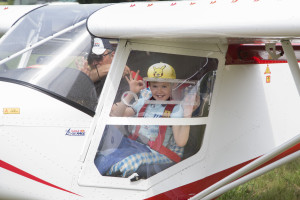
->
xmin=87 ymin=0 xmax=300 ymax=43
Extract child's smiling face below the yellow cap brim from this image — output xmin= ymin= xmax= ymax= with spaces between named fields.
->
xmin=150 ymin=82 xmax=172 ymax=101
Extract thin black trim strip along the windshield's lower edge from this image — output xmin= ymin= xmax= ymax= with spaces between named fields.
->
xmin=0 ymin=77 xmax=95 ymax=117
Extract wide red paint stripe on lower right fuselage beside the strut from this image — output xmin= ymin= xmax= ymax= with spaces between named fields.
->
xmin=147 ymin=143 xmax=300 ymax=200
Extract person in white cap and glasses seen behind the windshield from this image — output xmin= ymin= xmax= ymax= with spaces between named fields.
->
xmin=81 ymin=37 xmax=130 ymax=96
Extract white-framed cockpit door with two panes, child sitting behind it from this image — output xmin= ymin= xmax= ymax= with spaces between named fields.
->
xmin=78 ymin=40 xmax=224 ymax=191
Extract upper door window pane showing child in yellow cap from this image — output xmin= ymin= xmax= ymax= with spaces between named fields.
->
xmin=111 ymin=51 xmax=218 ymax=118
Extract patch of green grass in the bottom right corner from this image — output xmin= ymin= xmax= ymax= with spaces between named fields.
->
xmin=218 ymin=158 xmax=300 ymax=200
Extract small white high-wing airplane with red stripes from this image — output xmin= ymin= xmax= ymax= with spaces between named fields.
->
xmin=0 ymin=0 xmax=300 ymax=200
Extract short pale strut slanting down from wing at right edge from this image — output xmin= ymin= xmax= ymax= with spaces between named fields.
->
xmin=281 ymin=40 xmax=300 ymax=95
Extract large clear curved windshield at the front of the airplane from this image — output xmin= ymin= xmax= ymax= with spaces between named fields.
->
xmin=0 ymin=4 xmax=105 ymax=115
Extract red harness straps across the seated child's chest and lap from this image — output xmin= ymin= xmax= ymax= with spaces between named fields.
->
xmin=129 ymin=100 xmax=181 ymax=162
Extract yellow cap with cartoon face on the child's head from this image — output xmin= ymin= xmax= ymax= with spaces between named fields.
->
xmin=147 ymin=63 xmax=176 ymax=79
